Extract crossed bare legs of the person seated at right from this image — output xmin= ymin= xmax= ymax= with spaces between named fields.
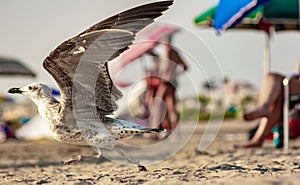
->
xmin=235 ymin=73 xmax=300 ymax=148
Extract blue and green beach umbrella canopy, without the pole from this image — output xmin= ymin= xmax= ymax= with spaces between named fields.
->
xmin=194 ymin=0 xmax=299 ymax=32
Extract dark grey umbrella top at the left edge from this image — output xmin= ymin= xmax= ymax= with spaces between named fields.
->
xmin=0 ymin=57 xmax=36 ymax=77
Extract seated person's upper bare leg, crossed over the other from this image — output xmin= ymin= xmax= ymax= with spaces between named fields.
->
xmin=244 ymin=73 xmax=284 ymax=120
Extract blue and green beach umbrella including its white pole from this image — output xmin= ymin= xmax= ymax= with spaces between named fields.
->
xmin=194 ymin=0 xmax=299 ymax=73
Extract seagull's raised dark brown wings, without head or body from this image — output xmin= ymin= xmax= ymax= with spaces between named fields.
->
xmin=43 ymin=1 xmax=173 ymax=114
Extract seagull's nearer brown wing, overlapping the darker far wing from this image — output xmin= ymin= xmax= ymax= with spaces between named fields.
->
xmin=43 ymin=29 xmax=134 ymax=107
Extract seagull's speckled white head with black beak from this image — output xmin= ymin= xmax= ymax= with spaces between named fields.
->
xmin=8 ymin=83 xmax=52 ymax=101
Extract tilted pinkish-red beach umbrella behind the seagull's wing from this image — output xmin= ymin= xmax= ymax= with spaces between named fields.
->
xmin=109 ymin=24 xmax=179 ymax=80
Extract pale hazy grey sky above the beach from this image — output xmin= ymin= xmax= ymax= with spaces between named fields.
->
xmin=0 ymin=0 xmax=300 ymax=98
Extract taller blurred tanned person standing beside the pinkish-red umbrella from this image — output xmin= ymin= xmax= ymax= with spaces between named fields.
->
xmin=150 ymin=36 xmax=188 ymax=138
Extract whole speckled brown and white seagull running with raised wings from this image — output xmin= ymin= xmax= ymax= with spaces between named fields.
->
xmin=8 ymin=0 xmax=173 ymax=171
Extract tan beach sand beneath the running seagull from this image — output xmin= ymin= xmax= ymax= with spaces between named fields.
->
xmin=0 ymin=121 xmax=300 ymax=185
